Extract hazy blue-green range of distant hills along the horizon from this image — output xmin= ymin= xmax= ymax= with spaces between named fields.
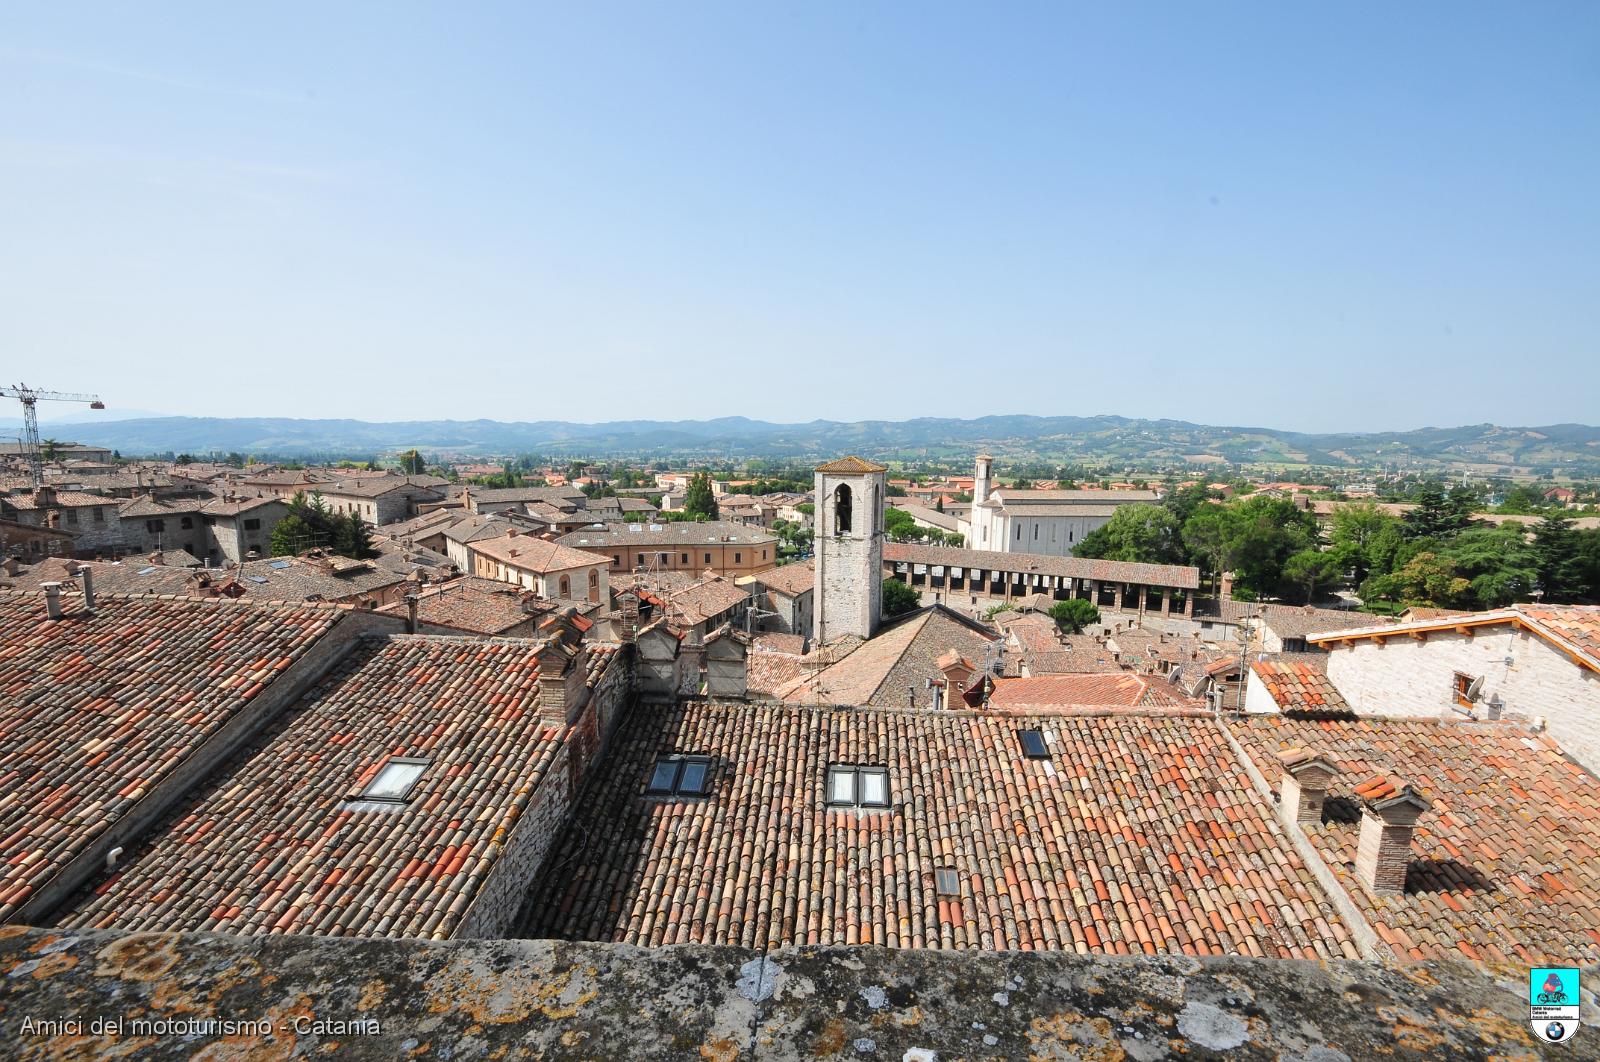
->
xmin=0 ymin=416 xmax=1600 ymax=475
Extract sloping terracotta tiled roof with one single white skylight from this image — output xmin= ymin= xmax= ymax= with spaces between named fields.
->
xmin=59 ymin=637 xmax=566 ymax=937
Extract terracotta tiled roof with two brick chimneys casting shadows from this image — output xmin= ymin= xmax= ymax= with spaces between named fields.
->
xmin=1230 ymin=717 xmax=1600 ymax=966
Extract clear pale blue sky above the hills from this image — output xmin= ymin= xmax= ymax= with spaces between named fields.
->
xmin=0 ymin=3 xmax=1600 ymax=430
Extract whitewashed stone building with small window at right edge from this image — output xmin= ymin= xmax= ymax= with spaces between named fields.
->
xmin=1307 ymin=605 xmax=1600 ymax=769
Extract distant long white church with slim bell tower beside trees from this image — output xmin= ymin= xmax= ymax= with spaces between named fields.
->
xmin=960 ymin=454 xmax=1160 ymax=557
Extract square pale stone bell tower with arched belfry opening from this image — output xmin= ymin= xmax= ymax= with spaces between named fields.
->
xmin=811 ymin=457 xmax=885 ymax=645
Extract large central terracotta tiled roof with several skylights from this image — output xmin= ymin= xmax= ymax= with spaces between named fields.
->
xmin=525 ymin=702 xmax=1357 ymax=958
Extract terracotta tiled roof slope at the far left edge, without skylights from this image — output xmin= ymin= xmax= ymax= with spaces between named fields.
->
xmin=0 ymin=592 xmax=342 ymax=920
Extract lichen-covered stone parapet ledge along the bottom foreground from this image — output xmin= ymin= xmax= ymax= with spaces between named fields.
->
xmin=0 ymin=928 xmax=1580 ymax=1062
